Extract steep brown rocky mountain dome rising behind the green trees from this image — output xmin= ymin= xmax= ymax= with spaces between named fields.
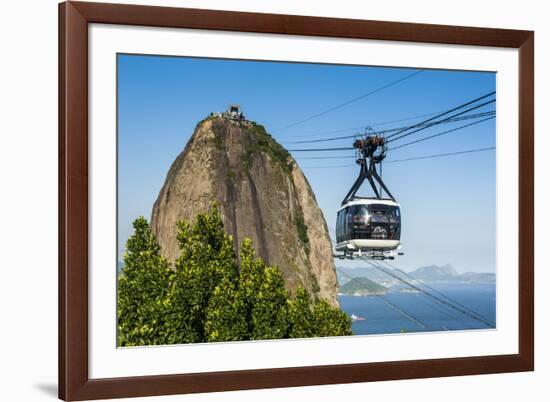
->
xmin=151 ymin=117 xmax=338 ymax=305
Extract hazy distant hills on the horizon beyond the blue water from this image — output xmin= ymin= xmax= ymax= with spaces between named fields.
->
xmin=337 ymin=264 xmax=496 ymax=289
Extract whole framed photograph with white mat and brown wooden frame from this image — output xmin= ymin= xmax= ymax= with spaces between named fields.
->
xmin=59 ymin=1 xmax=534 ymax=400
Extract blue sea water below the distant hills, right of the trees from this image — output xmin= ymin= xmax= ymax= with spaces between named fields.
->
xmin=339 ymin=283 xmax=496 ymax=335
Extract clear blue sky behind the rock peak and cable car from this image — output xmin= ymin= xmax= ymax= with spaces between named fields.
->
xmin=118 ymin=55 xmax=496 ymax=272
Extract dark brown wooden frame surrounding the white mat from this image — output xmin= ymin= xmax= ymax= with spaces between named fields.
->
xmin=59 ymin=2 xmax=534 ymax=400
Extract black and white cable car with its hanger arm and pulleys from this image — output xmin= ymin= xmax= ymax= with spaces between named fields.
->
xmin=335 ymin=130 xmax=401 ymax=259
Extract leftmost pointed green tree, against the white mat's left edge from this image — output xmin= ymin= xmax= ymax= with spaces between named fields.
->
xmin=117 ymin=217 xmax=173 ymax=346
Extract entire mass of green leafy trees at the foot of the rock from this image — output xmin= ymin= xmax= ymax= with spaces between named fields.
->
xmin=118 ymin=206 xmax=351 ymax=346
